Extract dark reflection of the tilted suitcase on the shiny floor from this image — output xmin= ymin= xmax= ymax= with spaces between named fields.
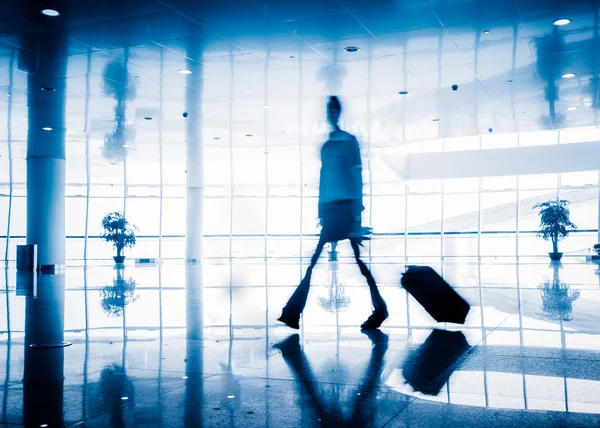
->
xmin=402 ymin=329 xmax=471 ymax=395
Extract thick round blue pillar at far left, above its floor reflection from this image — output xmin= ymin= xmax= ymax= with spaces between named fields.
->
xmin=19 ymin=2 xmax=68 ymax=266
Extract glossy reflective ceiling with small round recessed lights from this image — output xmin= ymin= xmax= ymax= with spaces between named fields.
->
xmin=0 ymin=0 xmax=600 ymax=181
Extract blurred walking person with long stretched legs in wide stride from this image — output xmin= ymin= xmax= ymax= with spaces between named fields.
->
xmin=279 ymin=97 xmax=388 ymax=329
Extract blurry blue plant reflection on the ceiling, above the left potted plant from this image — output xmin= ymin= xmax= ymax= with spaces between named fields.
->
xmin=102 ymin=60 xmax=137 ymax=163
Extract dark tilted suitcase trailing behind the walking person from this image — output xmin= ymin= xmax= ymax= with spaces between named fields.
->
xmin=400 ymin=266 xmax=470 ymax=324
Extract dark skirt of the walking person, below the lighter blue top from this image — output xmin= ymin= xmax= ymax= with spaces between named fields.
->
xmin=319 ymin=200 xmax=368 ymax=242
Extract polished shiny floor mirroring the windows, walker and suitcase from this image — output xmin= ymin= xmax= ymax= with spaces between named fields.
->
xmin=0 ymin=260 xmax=600 ymax=427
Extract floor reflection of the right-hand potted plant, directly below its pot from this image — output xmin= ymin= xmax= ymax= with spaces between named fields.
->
xmin=538 ymin=263 xmax=580 ymax=321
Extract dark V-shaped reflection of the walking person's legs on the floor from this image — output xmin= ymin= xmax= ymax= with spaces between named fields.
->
xmin=274 ymin=330 xmax=388 ymax=427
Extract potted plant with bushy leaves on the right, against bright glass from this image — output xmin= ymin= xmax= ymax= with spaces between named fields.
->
xmin=533 ymin=199 xmax=577 ymax=261
